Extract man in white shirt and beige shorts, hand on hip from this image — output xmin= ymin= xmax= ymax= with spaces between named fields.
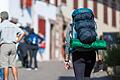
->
xmin=0 ymin=11 xmax=24 ymax=80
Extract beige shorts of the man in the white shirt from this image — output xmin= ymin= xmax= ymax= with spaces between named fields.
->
xmin=0 ymin=43 xmax=16 ymax=68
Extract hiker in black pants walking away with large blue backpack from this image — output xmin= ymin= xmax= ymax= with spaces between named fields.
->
xmin=64 ymin=8 xmax=97 ymax=80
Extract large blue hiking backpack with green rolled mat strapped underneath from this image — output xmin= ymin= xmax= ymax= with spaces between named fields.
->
xmin=67 ymin=8 xmax=107 ymax=51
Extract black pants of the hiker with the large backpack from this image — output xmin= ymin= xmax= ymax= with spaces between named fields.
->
xmin=72 ymin=51 xmax=96 ymax=80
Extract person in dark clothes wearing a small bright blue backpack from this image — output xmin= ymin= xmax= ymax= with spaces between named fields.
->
xmin=26 ymin=28 xmax=44 ymax=70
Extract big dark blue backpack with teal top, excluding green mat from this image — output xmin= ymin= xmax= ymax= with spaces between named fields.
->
xmin=72 ymin=8 xmax=97 ymax=44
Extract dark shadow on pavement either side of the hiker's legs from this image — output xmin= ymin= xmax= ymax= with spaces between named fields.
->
xmin=58 ymin=76 xmax=112 ymax=80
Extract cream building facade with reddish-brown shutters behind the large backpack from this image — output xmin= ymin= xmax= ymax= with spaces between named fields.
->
xmin=54 ymin=0 xmax=120 ymax=60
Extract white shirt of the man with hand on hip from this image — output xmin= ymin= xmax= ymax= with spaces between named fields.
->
xmin=0 ymin=20 xmax=24 ymax=44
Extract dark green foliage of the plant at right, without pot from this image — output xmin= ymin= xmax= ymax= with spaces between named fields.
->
xmin=105 ymin=45 xmax=120 ymax=66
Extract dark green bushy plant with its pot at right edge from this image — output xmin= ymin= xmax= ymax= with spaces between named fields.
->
xmin=105 ymin=45 xmax=120 ymax=76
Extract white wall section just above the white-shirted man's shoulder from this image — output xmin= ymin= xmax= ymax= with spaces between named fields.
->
xmin=9 ymin=0 xmax=32 ymax=26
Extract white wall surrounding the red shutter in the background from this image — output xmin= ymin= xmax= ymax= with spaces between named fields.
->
xmin=33 ymin=1 xmax=57 ymax=60
